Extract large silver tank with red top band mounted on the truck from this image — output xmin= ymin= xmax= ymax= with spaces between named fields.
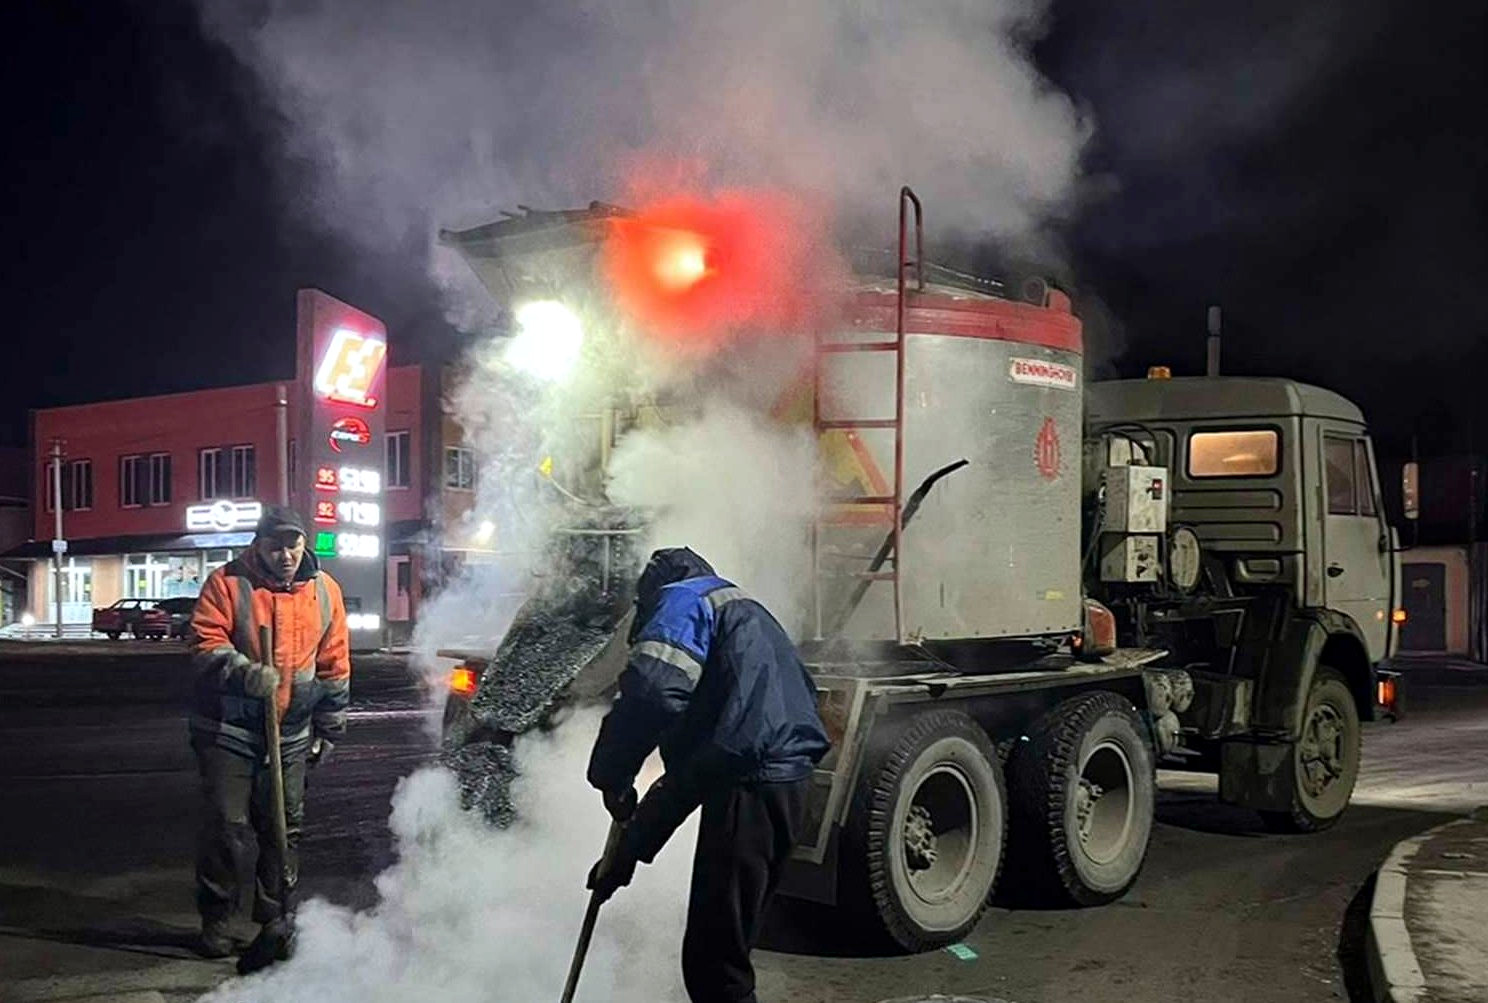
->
xmin=818 ymin=284 xmax=1083 ymax=641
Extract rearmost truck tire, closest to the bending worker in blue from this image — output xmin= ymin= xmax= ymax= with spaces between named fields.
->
xmin=842 ymin=710 xmax=1007 ymax=951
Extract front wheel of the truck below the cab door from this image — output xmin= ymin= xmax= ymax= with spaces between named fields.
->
xmin=1260 ymin=665 xmax=1362 ymax=832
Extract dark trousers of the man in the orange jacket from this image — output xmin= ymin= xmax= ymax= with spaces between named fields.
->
xmin=192 ymin=740 xmax=305 ymax=923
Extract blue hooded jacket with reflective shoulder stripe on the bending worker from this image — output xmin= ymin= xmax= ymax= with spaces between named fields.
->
xmin=589 ymin=548 xmax=830 ymax=860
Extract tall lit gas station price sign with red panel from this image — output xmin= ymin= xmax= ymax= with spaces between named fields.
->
xmin=295 ymin=289 xmax=387 ymax=650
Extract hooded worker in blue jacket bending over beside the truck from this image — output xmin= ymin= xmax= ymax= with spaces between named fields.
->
xmin=589 ymin=548 xmax=830 ymax=1003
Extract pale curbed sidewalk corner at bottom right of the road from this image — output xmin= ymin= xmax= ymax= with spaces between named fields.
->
xmin=1369 ymin=808 xmax=1488 ymax=1003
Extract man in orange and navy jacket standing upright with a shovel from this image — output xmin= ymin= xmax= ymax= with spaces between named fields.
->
xmin=190 ymin=506 xmax=351 ymax=970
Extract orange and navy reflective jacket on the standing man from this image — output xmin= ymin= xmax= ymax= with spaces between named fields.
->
xmin=190 ymin=551 xmax=351 ymax=756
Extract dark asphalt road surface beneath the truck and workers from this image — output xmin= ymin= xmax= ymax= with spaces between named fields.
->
xmin=0 ymin=646 xmax=1488 ymax=1003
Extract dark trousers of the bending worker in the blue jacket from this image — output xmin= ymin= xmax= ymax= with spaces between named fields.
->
xmin=682 ymin=780 xmax=811 ymax=1003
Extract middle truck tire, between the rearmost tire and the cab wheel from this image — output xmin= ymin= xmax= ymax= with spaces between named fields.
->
xmin=1009 ymin=692 xmax=1158 ymax=906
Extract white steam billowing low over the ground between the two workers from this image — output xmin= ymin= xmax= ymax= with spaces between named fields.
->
xmin=207 ymin=716 xmax=696 ymax=1003
